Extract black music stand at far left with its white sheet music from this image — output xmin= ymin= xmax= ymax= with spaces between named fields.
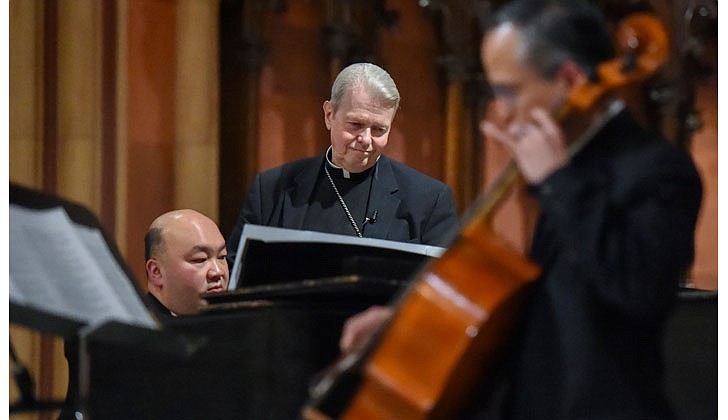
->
xmin=9 ymin=183 xmax=159 ymax=413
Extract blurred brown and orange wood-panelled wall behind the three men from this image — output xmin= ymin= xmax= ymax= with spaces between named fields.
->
xmin=9 ymin=0 xmax=718 ymax=418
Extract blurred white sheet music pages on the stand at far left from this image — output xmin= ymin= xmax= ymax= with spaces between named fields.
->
xmin=9 ymin=204 xmax=157 ymax=328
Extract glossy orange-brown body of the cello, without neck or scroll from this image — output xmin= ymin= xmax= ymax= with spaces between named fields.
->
xmin=341 ymin=223 xmax=539 ymax=420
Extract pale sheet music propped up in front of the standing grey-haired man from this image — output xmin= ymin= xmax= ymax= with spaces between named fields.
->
xmin=228 ymin=224 xmax=446 ymax=290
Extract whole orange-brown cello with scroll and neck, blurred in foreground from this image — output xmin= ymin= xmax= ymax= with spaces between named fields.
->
xmin=304 ymin=14 xmax=669 ymax=420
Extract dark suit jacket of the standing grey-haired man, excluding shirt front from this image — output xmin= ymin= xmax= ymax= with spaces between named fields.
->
xmin=228 ymin=155 xmax=459 ymax=262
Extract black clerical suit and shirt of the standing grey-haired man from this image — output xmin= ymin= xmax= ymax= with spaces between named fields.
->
xmin=227 ymin=155 xmax=459 ymax=263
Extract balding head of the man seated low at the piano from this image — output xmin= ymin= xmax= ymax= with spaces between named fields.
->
xmin=144 ymin=209 xmax=229 ymax=317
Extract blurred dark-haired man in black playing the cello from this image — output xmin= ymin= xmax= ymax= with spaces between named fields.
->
xmin=334 ymin=0 xmax=702 ymax=420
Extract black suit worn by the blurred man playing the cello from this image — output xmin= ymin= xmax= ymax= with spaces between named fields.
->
xmin=480 ymin=112 xmax=701 ymax=420
